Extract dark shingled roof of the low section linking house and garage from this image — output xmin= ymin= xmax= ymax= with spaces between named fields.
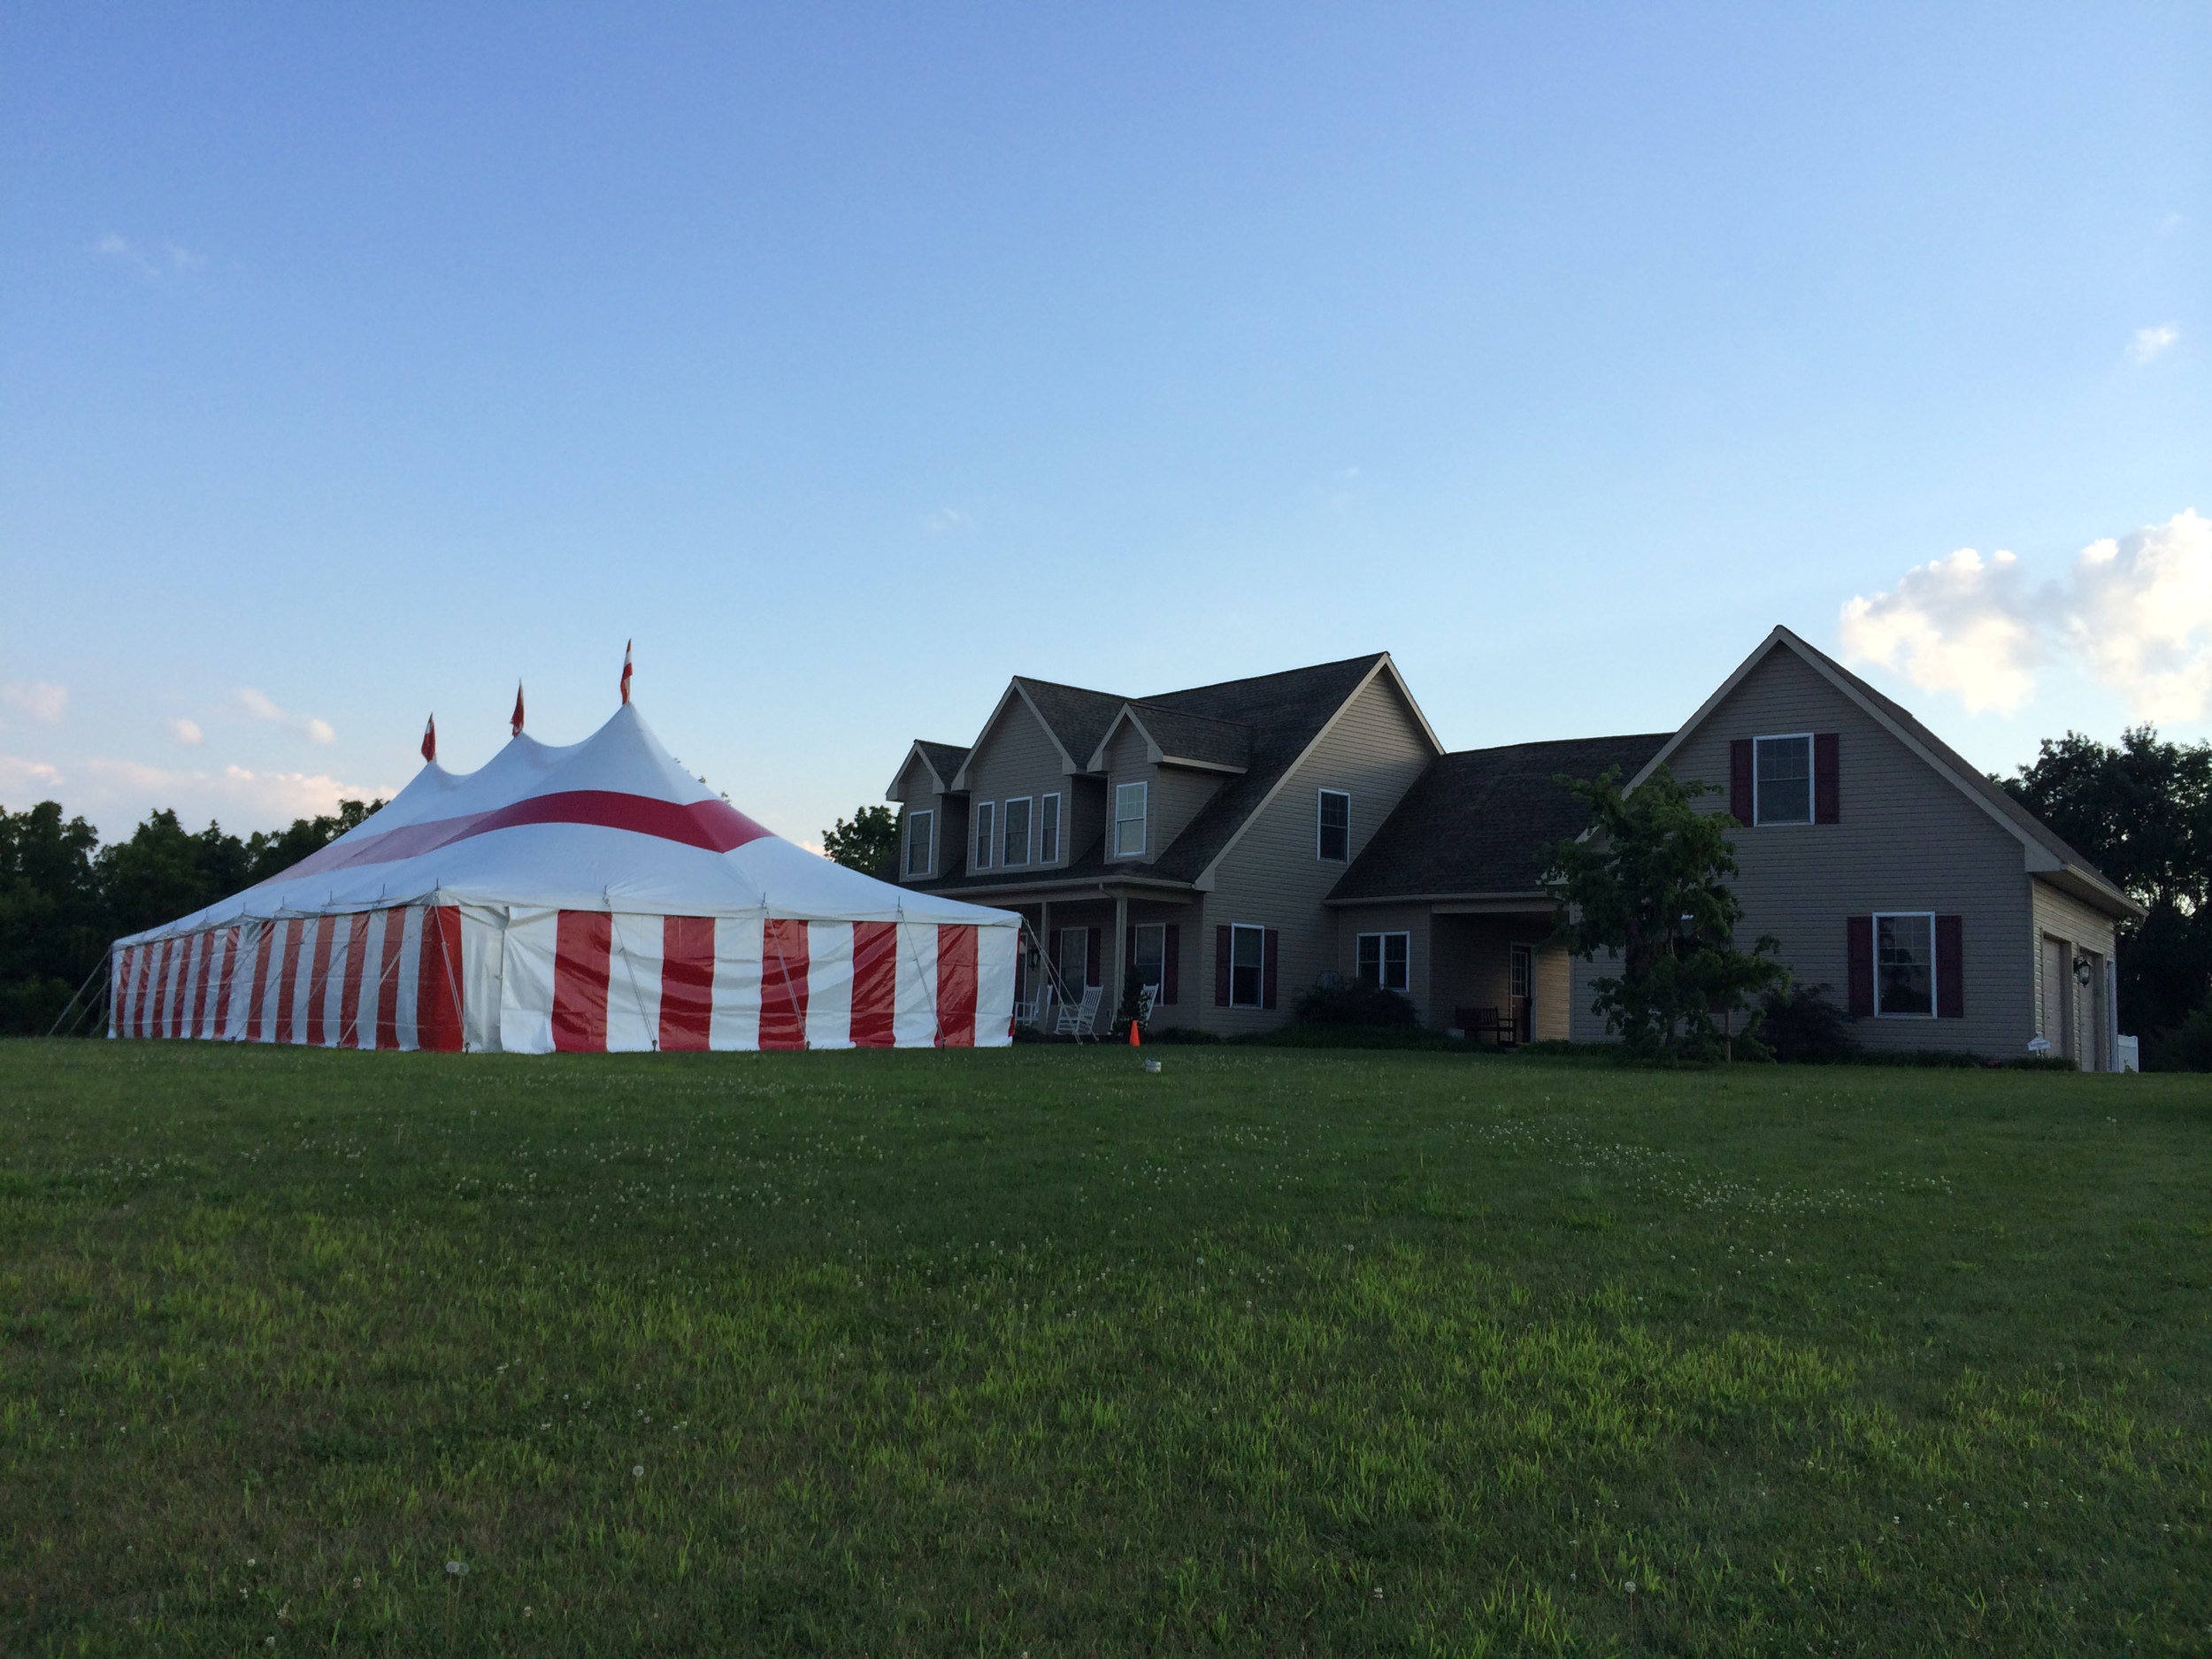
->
xmin=1330 ymin=733 xmax=1672 ymax=901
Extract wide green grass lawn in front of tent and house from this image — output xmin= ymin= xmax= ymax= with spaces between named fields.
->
xmin=0 ymin=1042 xmax=2212 ymax=1659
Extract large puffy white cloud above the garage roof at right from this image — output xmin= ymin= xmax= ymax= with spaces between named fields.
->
xmin=1840 ymin=511 xmax=2212 ymax=721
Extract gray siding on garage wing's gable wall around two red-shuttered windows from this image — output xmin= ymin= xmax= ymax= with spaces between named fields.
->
xmin=1575 ymin=649 xmax=2035 ymax=1056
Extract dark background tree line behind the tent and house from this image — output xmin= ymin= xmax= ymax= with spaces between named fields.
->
xmin=12 ymin=726 xmax=2212 ymax=1071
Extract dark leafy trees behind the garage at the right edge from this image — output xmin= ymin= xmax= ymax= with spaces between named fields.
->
xmin=2000 ymin=726 xmax=2212 ymax=1038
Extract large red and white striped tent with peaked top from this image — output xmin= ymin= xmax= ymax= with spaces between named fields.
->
xmin=109 ymin=703 xmax=1020 ymax=1056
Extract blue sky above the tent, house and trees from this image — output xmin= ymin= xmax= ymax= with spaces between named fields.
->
xmin=0 ymin=4 xmax=2212 ymax=841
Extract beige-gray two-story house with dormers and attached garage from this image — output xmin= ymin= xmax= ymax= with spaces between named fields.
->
xmin=889 ymin=628 xmax=2139 ymax=1069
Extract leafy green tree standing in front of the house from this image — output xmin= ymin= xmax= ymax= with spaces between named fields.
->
xmin=1544 ymin=765 xmax=1790 ymax=1062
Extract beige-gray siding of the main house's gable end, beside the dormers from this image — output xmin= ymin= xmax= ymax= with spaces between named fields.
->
xmin=1203 ymin=675 xmax=1436 ymax=1033
